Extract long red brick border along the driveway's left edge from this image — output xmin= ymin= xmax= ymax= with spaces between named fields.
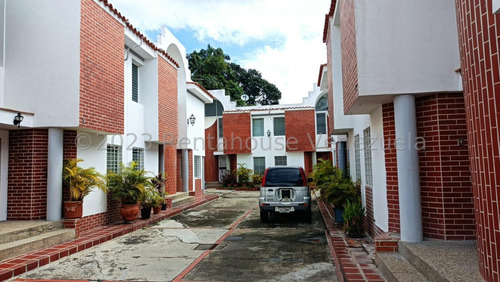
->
xmin=0 ymin=195 xmax=219 ymax=282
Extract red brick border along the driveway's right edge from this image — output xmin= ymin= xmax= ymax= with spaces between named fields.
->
xmin=316 ymin=198 xmax=386 ymax=282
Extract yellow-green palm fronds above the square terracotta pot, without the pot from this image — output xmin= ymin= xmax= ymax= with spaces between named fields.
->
xmin=63 ymin=159 xmax=108 ymax=201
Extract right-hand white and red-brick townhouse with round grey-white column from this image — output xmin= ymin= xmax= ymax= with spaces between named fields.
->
xmin=323 ymin=0 xmax=500 ymax=281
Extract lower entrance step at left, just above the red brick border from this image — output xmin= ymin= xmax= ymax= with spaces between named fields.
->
xmin=0 ymin=229 xmax=75 ymax=261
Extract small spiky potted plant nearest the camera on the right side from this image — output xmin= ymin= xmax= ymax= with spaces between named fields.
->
xmin=342 ymin=199 xmax=366 ymax=238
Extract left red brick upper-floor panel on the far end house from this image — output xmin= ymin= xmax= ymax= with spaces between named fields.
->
xmin=222 ymin=113 xmax=252 ymax=154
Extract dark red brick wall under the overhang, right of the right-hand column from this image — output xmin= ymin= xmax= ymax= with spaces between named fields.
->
xmin=416 ymin=94 xmax=476 ymax=240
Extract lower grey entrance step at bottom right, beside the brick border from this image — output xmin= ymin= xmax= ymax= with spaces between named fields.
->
xmin=375 ymin=252 xmax=428 ymax=282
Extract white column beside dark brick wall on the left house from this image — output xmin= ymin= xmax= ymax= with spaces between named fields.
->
xmin=47 ymin=128 xmax=63 ymax=221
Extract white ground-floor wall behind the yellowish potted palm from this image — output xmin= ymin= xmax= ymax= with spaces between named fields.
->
xmin=77 ymin=131 xmax=107 ymax=216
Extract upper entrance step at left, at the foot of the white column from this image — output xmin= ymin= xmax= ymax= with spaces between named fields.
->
xmin=0 ymin=221 xmax=63 ymax=244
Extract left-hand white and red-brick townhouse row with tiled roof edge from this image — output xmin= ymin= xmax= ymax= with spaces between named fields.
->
xmin=0 ymin=0 xmax=208 ymax=234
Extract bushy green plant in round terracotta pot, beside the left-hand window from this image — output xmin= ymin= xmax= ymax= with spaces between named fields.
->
xmin=106 ymin=162 xmax=153 ymax=222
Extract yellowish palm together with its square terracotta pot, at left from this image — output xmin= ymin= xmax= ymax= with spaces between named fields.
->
xmin=63 ymin=159 xmax=108 ymax=219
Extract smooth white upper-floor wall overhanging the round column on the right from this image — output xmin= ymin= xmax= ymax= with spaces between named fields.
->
xmin=355 ymin=0 xmax=461 ymax=96
